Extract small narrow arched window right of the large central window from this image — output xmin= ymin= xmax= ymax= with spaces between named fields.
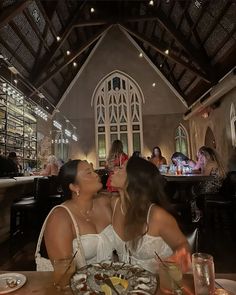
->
xmin=175 ymin=124 xmax=189 ymax=156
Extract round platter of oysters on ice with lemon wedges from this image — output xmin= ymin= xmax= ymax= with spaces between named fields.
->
xmin=71 ymin=261 xmax=157 ymax=295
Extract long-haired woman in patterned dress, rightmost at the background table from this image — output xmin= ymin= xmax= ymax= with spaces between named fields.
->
xmin=195 ymin=146 xmax=226 ymax=194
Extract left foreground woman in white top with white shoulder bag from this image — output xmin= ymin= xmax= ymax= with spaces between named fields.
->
xmin=35 ymin=160 xmax=113 ymax=271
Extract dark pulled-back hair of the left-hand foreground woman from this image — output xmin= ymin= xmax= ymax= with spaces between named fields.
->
xmin=58 ymin=160 xmax=82 ymax=200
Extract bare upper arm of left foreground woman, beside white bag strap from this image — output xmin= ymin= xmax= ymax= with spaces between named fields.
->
xmin=44 ymin=208 xmax=74 ymax=261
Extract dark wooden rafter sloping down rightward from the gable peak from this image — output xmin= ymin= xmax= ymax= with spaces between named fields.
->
xmin=121 ymin=25 xmax=210 ymax=83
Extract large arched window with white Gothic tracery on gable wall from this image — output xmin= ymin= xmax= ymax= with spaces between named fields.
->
xmin=92 ymin=71 xmax=143 ymax=167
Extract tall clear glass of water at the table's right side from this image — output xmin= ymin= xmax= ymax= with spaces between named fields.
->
xmin=192 ymin=253 xmax=215 ymax=295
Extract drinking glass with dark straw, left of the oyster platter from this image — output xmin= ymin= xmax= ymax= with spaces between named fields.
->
xmin=53 ymin=257 xmax=76 ymax=290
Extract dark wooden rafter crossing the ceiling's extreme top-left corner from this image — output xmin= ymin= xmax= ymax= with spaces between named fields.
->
xmin=0 ymin=0 xmax=32 ymax=28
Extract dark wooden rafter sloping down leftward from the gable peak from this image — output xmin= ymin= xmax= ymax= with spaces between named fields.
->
xmin=35 ymin=26 xmax=110 ymax=88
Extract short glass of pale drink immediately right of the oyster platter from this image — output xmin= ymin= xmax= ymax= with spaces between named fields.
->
xmin=159 ymin=261 xmax=183 ymax=294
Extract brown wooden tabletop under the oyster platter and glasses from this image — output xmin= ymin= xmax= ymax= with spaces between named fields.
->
xmin=0 ymin=271 xmax=236 ymax=295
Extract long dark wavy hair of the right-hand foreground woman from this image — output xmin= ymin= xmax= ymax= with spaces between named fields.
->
xmin=125 ymin=157 xmax=171 ymax=248
